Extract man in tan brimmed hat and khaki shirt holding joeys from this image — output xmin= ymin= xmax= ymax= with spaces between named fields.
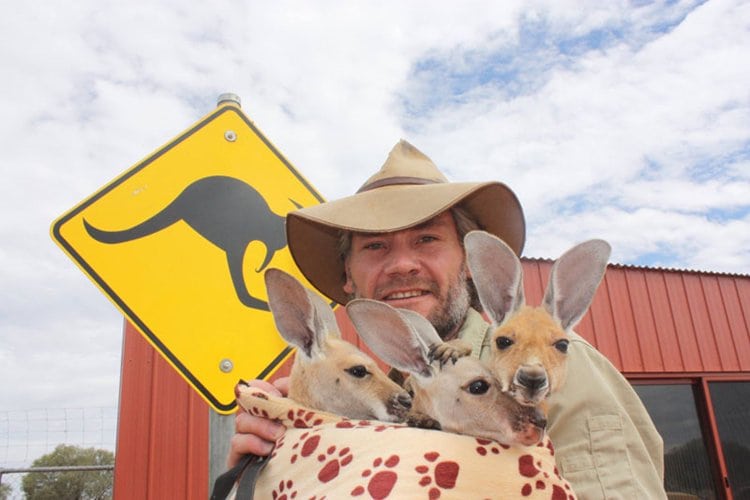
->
xmin=227 ymin=141 xmax=666 ymax=499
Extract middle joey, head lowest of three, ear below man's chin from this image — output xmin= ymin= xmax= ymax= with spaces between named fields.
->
xmin=346 ymin=299 xmax=546 ymax=446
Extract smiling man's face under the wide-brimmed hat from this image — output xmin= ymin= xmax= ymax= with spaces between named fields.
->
xmin=344 ymin=212 xmax=469 ymax=338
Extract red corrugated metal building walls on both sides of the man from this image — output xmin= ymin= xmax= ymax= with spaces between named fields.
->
xmin=115 ymin=259 xmax=750 ymax=500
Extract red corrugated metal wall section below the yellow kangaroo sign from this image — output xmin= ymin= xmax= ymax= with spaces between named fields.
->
xmin=114 ymin=323 xmax=208 ymax=500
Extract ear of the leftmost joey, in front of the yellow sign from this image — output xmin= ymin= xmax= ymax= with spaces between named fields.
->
xmin=264 ymin=268 xmax=328 ymax=358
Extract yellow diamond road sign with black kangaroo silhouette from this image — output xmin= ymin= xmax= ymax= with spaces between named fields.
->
xmin=51 ymin=105 xmax=323 ymax=413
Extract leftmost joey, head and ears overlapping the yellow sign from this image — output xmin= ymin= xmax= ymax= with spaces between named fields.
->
xmin=258 ymin=269 xmax=411 ymax=422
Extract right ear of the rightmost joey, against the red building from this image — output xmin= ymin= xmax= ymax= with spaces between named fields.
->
xmin=543 ymin=240 xmax=611 ymax=330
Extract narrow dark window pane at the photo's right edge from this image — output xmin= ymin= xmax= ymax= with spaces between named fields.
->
xmin=708 ymin=382 xmax=750 ymax=500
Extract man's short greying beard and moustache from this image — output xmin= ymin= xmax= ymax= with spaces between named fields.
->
xmin=351 ymin=265 xmax=471 ymax=340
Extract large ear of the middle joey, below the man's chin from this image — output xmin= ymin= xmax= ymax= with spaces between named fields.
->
xmin=346 ymin=299 xmax=431 ymax=377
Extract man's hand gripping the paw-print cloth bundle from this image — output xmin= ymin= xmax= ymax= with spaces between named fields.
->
xmin=227 ymin=377 xmax=289 ymax=469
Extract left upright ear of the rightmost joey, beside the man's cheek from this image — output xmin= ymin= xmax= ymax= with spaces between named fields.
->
xmin=464 ymin=231 xmax=525 ymax=325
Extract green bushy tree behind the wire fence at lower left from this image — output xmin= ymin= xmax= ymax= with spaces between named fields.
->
xmin=21 ymin=444 xmax=115 ymax=500
